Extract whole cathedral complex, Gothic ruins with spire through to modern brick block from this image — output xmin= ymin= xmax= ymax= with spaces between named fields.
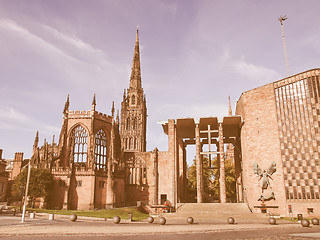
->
xmin=6 ymin=28 xmax=320 ymax=216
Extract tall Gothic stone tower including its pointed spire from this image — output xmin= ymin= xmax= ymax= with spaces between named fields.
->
xmin=120 ymin=29 xmax=147 ymax=152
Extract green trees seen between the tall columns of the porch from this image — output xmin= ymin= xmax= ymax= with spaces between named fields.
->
xmin=188 ymin=155 xmax=236 ymax=202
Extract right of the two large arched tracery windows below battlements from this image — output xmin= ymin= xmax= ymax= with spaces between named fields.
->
xmin=94 ymin=129 xmax=107 ymax=170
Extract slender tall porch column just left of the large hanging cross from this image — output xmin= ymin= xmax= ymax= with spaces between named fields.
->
xmin=195 ymin=124 xmax=203 ymax=203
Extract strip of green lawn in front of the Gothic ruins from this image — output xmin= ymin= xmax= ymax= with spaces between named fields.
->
xmin=23 ymin=207 xmax=149 ymax=221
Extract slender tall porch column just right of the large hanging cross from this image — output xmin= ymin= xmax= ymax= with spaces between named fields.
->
xmin=219 ymin=123 xmax=227 ymax=203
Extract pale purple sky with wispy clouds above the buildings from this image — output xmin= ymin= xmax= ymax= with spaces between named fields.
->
xmin=0 ymin=0 xmax=320 ymax=159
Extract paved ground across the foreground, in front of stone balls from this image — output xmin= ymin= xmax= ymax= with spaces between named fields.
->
xmin=0 ymin=214 xmax=320 ymax=240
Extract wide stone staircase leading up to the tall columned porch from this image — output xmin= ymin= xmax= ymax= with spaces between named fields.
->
xmin=163 ymin=203 xmax=267 ymax=223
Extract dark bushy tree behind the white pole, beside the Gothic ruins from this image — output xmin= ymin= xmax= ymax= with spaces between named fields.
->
xmin=12 ymin=168 xmax=53 ymax=207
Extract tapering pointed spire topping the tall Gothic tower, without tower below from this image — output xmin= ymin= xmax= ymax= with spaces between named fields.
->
xmin=130 ymin=28 xmax=141 ymax=89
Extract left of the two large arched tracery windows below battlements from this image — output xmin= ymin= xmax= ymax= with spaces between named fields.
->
xmin=72 ymin=126 xmax=88 ymax=165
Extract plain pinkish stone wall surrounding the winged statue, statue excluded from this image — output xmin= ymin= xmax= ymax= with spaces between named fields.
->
xmin=236 ymin=84 xmax=286 ymax=215
